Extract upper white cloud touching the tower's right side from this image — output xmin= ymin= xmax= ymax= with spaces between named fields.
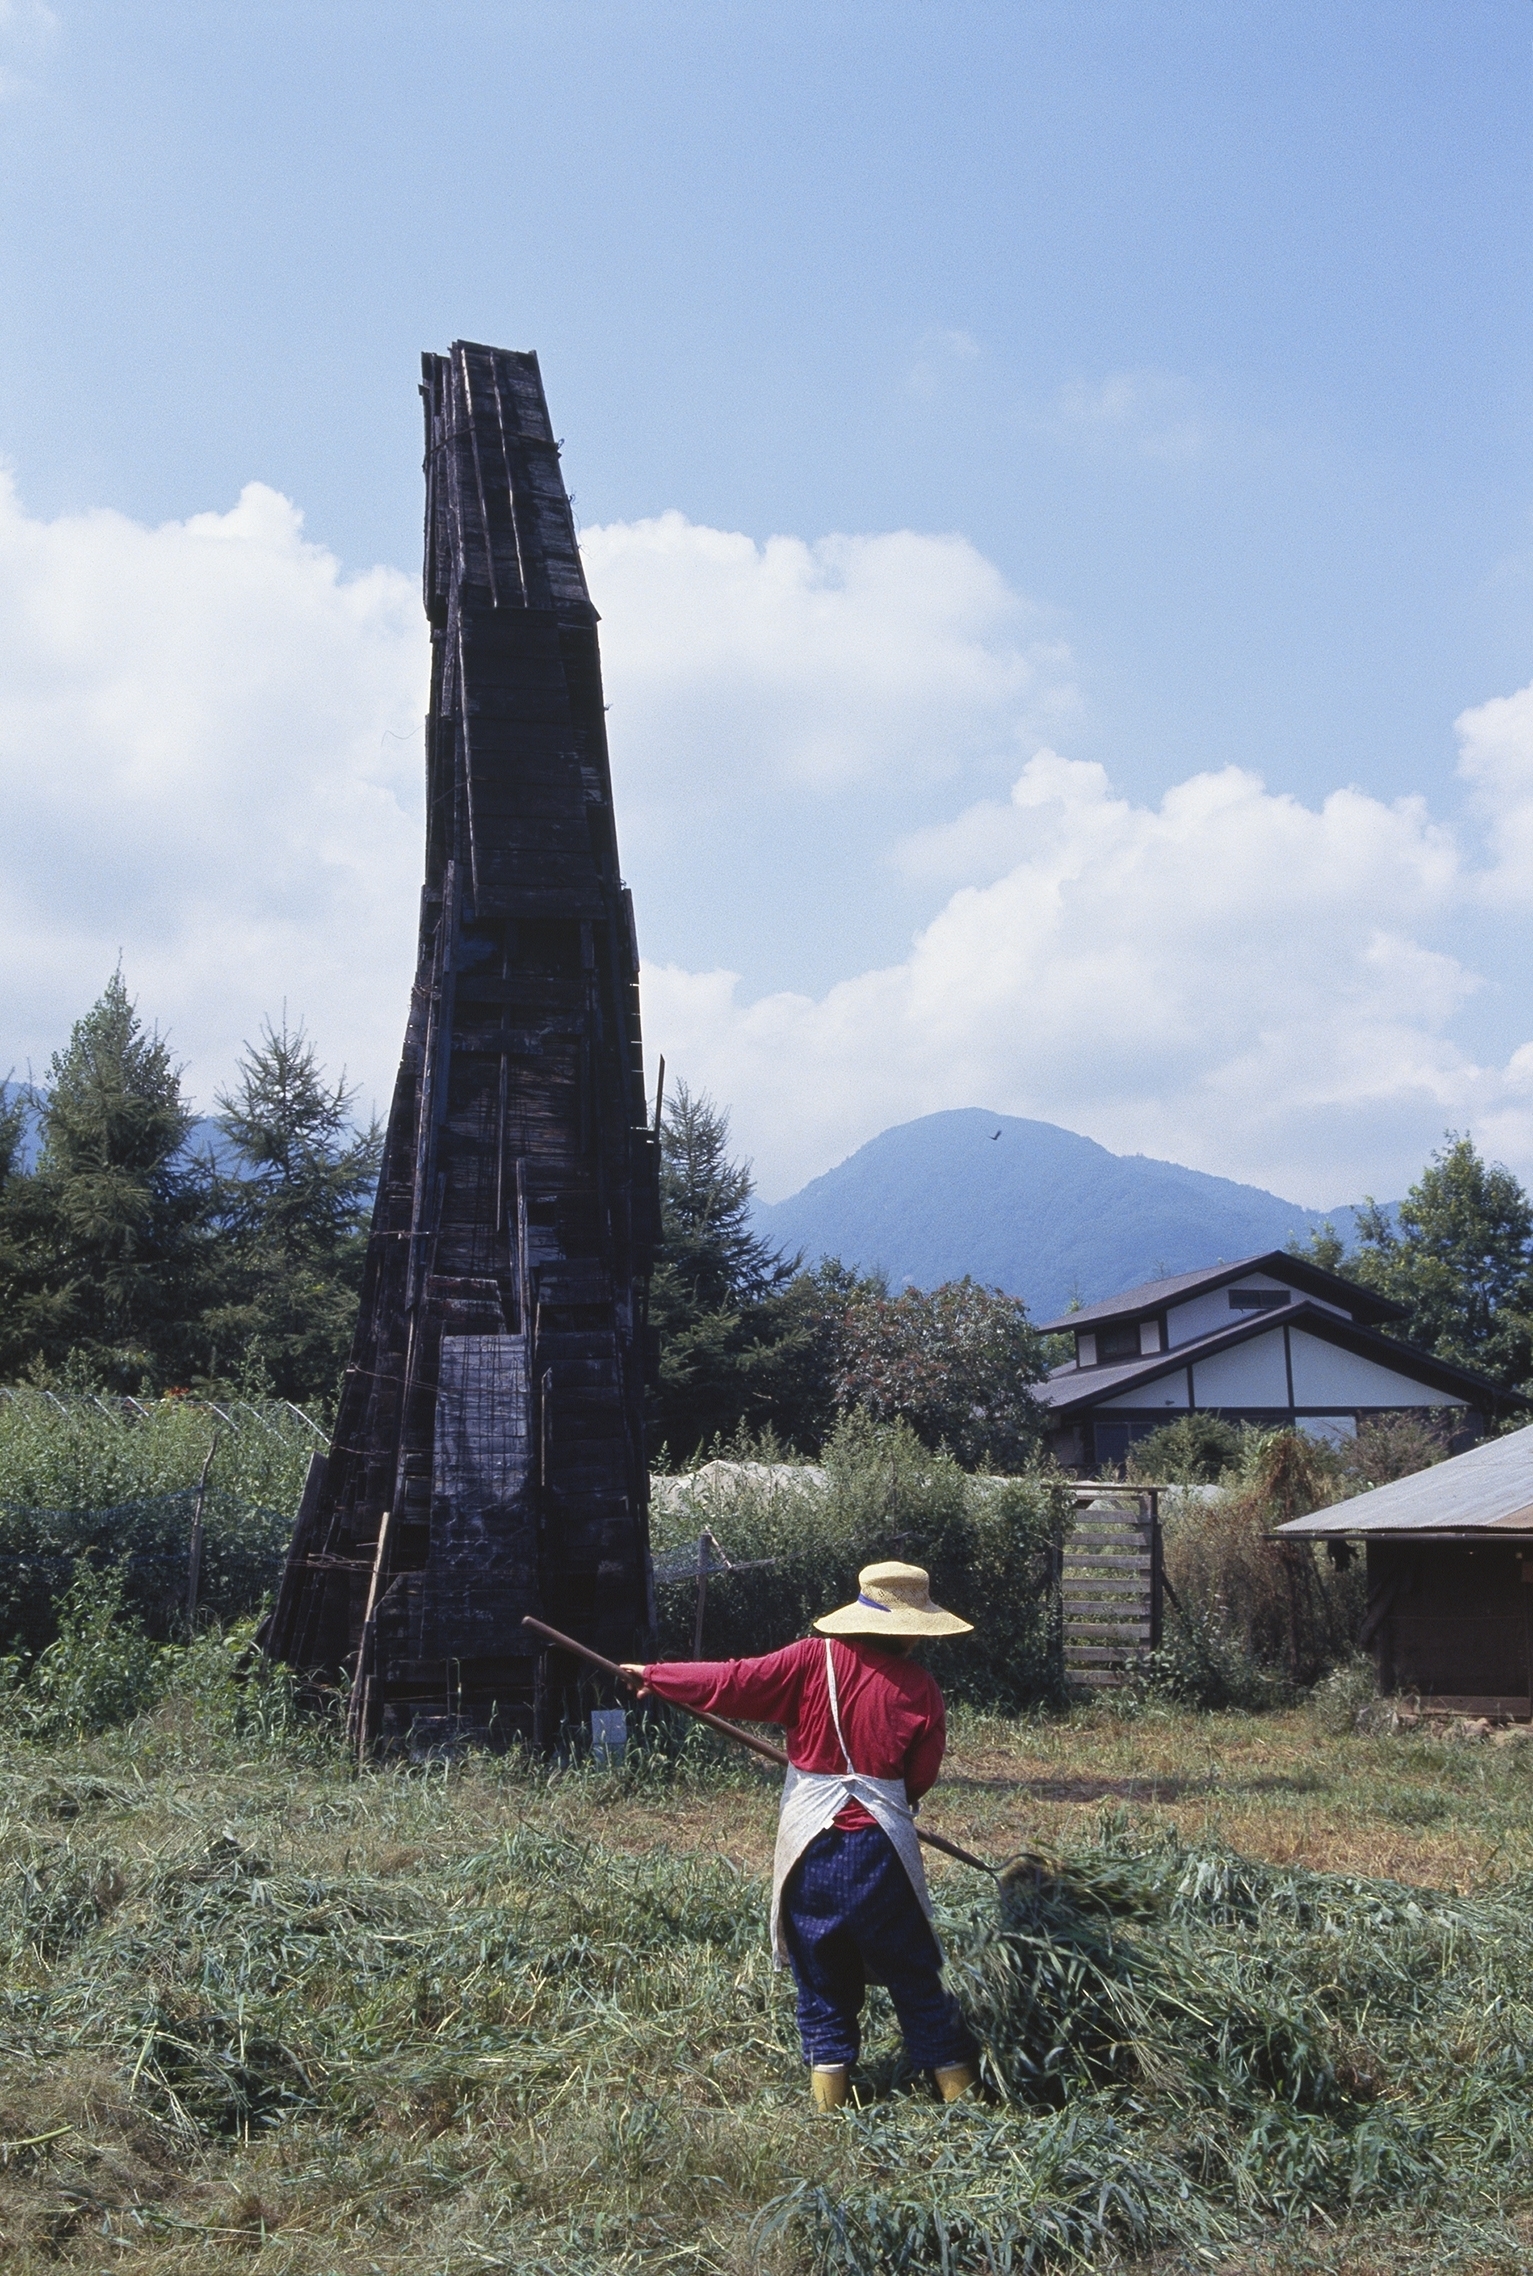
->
xmin=580 ymin=512 xmax=1076 ymax=806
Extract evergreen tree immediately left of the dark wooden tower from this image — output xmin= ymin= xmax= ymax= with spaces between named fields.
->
xmin=207 ymin=1013 xmax=382 ymax=1404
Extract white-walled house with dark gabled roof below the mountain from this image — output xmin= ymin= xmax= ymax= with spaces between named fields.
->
xmin=1037 ymin=1250 xmax=1526 ymax=1477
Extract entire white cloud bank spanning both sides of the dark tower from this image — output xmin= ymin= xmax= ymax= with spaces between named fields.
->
xmin=0 ymin=462 xmax=1533 ymax=1202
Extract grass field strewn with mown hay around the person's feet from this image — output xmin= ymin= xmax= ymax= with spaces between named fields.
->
xmin=0 ymin=1700 xmax=1533 ymax=2276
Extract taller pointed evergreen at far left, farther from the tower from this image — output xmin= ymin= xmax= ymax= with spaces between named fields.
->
xmin=0 ymin=970 xmax=212 ymax=1391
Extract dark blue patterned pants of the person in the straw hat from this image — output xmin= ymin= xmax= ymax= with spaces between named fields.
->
xmin=782 ymin=1825 xmax=973 ymax=2071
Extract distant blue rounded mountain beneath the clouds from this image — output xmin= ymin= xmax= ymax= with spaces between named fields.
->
xmin=755 ymin=1106 xmax=1382 ymax=1320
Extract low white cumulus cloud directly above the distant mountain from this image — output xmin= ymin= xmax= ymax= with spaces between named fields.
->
xmin=646 ymin=732 xmax=1533 ymax=1204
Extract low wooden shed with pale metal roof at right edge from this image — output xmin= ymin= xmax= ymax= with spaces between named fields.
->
xmin=1278 ymin=1425 xmax=1533 ymax=1721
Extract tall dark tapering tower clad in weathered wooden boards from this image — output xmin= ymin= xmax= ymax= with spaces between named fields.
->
xmin=266 ymin=341 xmax=657 ymax=1748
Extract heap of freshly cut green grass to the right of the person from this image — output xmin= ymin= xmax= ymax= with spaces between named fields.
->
xmin=767 ymin=1848 xmax=1533 ymax=2276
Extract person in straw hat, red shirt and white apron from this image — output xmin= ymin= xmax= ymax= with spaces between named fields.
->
xmin=623 ymin=1564 xmax=978 ymax=2110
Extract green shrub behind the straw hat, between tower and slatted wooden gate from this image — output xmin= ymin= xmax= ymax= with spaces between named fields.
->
xmin=653 ymin=1409 xmax=1069 ymax=1709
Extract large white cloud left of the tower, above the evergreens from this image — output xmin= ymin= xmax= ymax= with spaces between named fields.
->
xmin=0 ymin=483 xmax=428 ymax=1104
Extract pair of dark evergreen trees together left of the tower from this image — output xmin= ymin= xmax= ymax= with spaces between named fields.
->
xmin=0 ymin=972 xmax=378 ymax=1402
